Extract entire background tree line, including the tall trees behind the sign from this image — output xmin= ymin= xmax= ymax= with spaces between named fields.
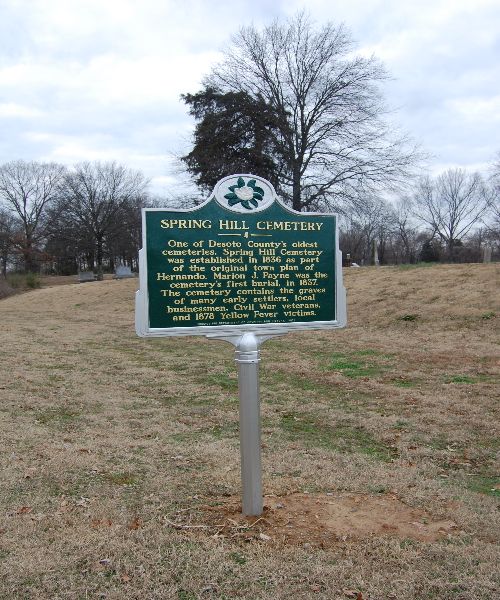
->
xmin=0 ymin=13 xmax=500 ymax=276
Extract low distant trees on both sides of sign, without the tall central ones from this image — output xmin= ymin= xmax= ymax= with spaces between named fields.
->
xmin=0 ymin=159 xmax=500 ymax=277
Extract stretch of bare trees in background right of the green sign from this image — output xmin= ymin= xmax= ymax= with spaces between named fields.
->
xmin=340 ymin=168 xmax=500 ymax=264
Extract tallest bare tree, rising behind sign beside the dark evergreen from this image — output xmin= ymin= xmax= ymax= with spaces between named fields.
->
xmin=205 ymin=13 xmax=420 ymax=210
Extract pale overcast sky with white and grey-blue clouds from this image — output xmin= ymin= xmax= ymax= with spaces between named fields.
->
xmin=0 ymin=0 xmax=500 ymax=195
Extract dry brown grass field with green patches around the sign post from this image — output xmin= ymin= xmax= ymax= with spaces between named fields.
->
xmin=0 ymin=264 xmax=500 ymax=600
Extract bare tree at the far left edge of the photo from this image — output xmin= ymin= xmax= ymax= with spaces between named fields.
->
xmin=0 ymin=160 xmax=64 ymax=271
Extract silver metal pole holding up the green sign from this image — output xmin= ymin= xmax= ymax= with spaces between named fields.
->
xmin=234 ymin=333 xmax=262 ymax=516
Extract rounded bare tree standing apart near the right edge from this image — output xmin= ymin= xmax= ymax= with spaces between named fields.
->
xmin=414 ymin=169 xmax=488 ymax=258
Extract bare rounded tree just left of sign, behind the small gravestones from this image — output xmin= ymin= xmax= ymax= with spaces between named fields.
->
xmin=58 ymin=162 xmax=147 ymax=277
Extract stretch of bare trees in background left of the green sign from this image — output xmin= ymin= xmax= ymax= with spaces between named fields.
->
xmin=0 ymin=160 xmax=151 ymax=276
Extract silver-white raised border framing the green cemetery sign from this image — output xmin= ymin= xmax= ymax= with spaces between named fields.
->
xmin=135 ymin=173 xmax=347 ymax=341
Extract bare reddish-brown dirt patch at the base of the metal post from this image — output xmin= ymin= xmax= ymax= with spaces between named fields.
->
xmin=189 ymin=493 xmax=457 ymax=548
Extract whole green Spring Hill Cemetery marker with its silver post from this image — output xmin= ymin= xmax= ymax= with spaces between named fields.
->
xmin=136 ymin=175 xmax=347 ymax=515
